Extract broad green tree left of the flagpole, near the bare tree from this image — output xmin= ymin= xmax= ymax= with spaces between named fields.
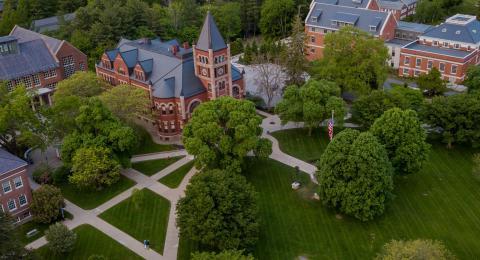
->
xmin=276 ymin=80 xmax=346 ymax=135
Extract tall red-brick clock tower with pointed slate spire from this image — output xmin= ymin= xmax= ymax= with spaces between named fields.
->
xmin=193 ymin=12 xmax=233 ymax=99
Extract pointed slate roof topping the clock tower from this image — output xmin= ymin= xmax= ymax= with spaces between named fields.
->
xmin=196 ymin=11 xmax=227 ymax=51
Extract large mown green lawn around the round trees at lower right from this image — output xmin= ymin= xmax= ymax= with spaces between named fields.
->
xmin=179 ymin=145 xmax=480 ymax=259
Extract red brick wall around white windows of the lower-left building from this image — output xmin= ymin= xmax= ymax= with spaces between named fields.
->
xmin=0 ymin=166 xmax=32 ymax=221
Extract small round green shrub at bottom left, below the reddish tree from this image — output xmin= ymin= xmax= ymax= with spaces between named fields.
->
xmin=45 ymin=223 xmax=77 ymax=255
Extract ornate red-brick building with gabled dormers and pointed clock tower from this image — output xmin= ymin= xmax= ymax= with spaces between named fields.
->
xmin=96 ymin=13 xmax=245 ymax=140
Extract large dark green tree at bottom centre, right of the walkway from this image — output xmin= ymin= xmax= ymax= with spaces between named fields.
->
xmin=177 ymin=170 xmax=259 ymax=250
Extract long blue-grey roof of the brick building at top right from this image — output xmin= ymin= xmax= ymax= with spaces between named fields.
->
xmin=305 ymin=3 xmax=388 ymax=36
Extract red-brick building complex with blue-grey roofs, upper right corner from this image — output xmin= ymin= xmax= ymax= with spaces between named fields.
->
xmin=305 ymin=0 xmax=480 ymax=84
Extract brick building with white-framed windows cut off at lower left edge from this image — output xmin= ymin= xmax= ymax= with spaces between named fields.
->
xmin=0 ymin=148 xmax=32 ymax=222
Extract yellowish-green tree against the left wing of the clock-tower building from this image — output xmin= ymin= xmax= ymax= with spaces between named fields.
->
xmin=100 ymin=85 xmax=151 ymax=122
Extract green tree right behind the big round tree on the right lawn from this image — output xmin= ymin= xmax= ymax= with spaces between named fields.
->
xmin=370 ymin=108 xmax=430 ymax=174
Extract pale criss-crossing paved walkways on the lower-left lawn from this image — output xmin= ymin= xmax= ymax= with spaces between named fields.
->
xmin=26 ymin=150 xmax=196 ymax=259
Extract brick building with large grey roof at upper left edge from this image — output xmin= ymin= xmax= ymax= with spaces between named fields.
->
xmin=0 ymin=26 xmax=87 ymax=108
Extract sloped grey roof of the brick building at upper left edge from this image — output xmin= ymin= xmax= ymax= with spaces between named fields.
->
xmin=0 ymin=39 xmax=58 ymax=80
